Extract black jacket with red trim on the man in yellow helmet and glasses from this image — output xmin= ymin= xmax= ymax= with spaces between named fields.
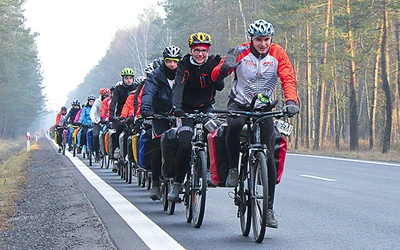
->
xmin=172 ymin=54 xmax=224 ymax=111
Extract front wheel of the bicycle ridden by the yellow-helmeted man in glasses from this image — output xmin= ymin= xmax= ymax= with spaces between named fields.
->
xmin=191 ymin=150 xmax=207 ymax=228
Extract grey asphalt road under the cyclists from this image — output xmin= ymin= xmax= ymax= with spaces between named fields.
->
xmin=60 ymin=142 xmax=400 ymax=250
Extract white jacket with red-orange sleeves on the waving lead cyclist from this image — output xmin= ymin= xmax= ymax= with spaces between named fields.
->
xmin=211 ymin=42 xmax=298 ymax=106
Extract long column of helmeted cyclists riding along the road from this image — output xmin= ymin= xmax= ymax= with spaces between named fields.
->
xmin=51 ymin=20 xmax=299 ymax=240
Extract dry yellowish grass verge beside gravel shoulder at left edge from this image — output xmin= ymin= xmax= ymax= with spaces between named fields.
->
xmin=0 ymin=143 xmax=38 ymax=231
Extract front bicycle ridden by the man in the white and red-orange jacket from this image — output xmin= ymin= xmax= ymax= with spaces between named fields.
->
xmin=212 ymin=95 xmax=288 ymax=243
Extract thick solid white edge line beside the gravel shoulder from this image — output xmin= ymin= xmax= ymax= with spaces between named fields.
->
xmin=51 ymin=140 xmax=185 ymax=250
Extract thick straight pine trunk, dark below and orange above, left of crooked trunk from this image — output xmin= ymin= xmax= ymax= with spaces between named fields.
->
xmin=346 ymin=0 xmax=358 ymax=151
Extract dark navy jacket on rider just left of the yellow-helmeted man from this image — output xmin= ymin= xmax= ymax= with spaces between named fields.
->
xmin=140 ymin=65 xmax=172 ymax=113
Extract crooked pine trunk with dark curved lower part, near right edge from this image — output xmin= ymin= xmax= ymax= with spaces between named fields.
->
xmin=381 ymin=0 xmax=392 ymax=154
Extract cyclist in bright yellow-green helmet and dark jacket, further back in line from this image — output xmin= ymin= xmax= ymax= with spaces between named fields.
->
xmin=110 ymin=68 xmax=136 ymax=172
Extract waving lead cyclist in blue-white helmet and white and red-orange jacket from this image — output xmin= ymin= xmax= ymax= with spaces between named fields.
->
xmin=212 ymin=20 xmax=298 ymax=228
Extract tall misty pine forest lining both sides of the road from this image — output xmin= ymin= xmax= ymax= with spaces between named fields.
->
xmin=0 ymin=0 xmax=400 ymax=154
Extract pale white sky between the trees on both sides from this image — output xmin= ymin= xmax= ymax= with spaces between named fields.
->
xmin=23 ymin=0 xmax=162 ymax=111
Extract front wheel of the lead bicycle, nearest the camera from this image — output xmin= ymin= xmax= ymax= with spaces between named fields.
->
xmin=250 ymin=152 xmax=268 ymax=243
